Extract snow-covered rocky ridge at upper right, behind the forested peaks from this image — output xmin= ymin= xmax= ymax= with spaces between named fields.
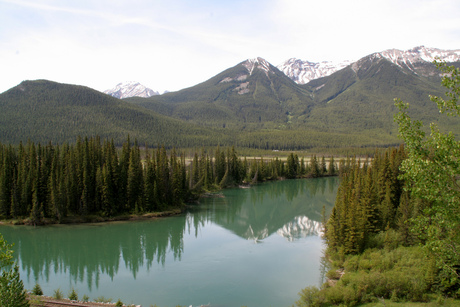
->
xmin=277 ymin=46 xmax=460 ymax=84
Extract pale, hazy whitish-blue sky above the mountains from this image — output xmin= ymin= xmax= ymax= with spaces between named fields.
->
xmin=0 ymin=0 xmax=460 ymax=93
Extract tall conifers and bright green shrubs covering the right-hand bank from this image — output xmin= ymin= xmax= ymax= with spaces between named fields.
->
xmin=296 ymin=146 xmax=460 ymax=307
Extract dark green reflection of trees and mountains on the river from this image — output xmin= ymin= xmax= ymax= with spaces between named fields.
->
xmin=0 ymin=178 xmax=338 ymax=300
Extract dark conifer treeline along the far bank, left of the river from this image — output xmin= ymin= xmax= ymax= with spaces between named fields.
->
xmin=0 ymin=137 xmax=337 ymax=224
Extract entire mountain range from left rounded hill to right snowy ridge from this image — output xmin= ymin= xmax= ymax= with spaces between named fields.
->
xmin=0 ymin=47 xmax=460 ymax=150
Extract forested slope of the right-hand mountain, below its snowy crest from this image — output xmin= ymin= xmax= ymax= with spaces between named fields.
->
xmin=303 ymin=56 xmax=458 ymax=136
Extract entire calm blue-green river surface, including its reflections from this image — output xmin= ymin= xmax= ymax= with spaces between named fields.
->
xmin=0 ymin=178 xmax=338 ymax=307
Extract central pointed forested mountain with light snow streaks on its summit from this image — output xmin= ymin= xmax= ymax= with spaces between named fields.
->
xmin=127 ymin=58 xmax=312 ymax=130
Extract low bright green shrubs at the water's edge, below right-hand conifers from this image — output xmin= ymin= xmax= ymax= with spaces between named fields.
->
xmin=296 ymin=247 xmax=431 ymax=307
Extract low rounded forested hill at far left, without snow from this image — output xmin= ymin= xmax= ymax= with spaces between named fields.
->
xmin=0 ymin=80 xmax=228 ymax=146
